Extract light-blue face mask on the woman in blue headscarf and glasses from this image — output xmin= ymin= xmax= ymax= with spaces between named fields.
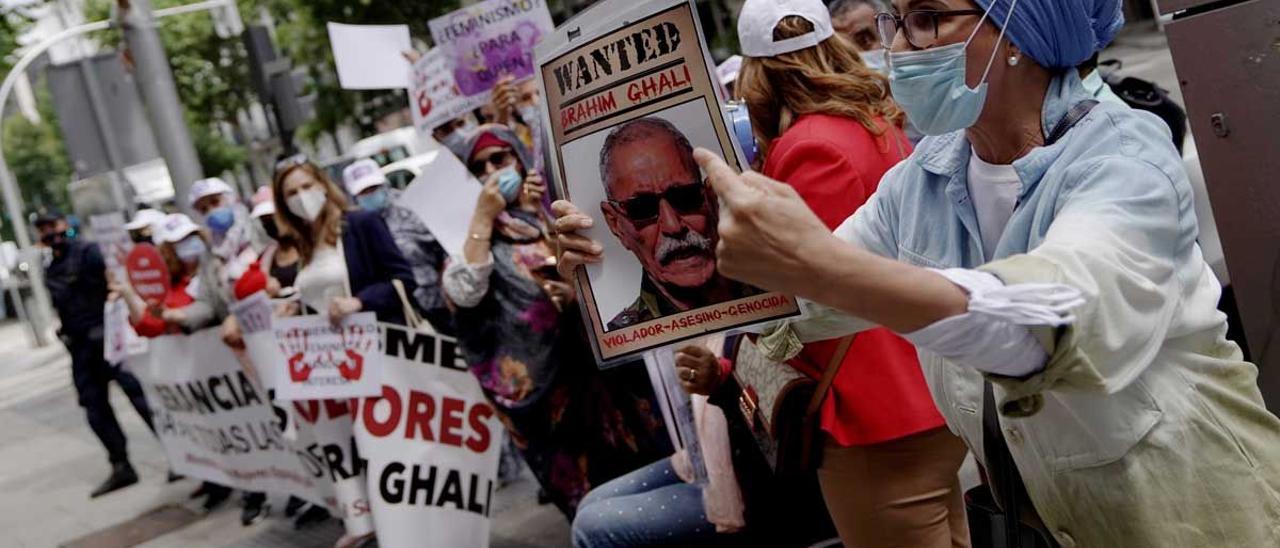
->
xmin=888 ymin=0 xmax=1018 ymax=136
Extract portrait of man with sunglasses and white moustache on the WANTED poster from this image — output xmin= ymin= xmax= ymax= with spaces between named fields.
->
xmin=600 ymin=117 xmax=760 ymax=330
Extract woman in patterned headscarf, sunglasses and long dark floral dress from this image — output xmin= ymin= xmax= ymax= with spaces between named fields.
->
xmin=444 ymin=125 xmax=671 ymax=517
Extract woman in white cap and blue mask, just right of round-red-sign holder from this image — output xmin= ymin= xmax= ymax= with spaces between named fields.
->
xmin=187 ymin=177 xmax=265 ymax=282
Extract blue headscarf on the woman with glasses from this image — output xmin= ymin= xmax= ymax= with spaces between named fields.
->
xmin=974 ymin=0 xmax=1124 ymax=69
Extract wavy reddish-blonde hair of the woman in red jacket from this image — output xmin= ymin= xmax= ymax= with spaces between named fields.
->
xmin=735 ymin=15 xmax=904 ymax=152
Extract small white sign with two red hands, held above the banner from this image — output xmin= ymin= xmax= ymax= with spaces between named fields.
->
xmin=266 ymin=312 xmax=381 ymax=401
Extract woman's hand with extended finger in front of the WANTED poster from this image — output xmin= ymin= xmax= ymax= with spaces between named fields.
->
xmin=694 ymin=149 xmax=835 ymax=294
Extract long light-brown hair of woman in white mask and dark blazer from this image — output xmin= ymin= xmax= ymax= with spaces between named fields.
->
xmin=271 ymin=161 xmax=349 ymax=265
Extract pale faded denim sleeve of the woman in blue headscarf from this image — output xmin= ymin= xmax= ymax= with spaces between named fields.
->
xmin=980 ymin=157 xmax=1194 ymax=415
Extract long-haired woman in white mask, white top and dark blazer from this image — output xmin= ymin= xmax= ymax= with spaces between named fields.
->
xmin=271 ymin=156 xmax=416 ymax=324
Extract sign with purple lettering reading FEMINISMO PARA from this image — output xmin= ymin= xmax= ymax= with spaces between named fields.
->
xmin=429 ymin=0 xmax=556 ymax=110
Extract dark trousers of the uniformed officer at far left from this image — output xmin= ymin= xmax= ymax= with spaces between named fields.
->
xmin=65 ymin=337 xmax=155 ymax=465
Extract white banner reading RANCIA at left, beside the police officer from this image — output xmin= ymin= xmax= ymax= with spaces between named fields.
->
xmin=127 ymin=328 xmax=335 ymax=508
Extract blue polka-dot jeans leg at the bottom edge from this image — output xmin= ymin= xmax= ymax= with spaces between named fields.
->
xmin=573 ymin=457 xmax=717 ymax=548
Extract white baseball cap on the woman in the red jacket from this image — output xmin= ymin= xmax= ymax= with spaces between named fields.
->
xmin=737 ymin=0 xmax=836 ymax=58
